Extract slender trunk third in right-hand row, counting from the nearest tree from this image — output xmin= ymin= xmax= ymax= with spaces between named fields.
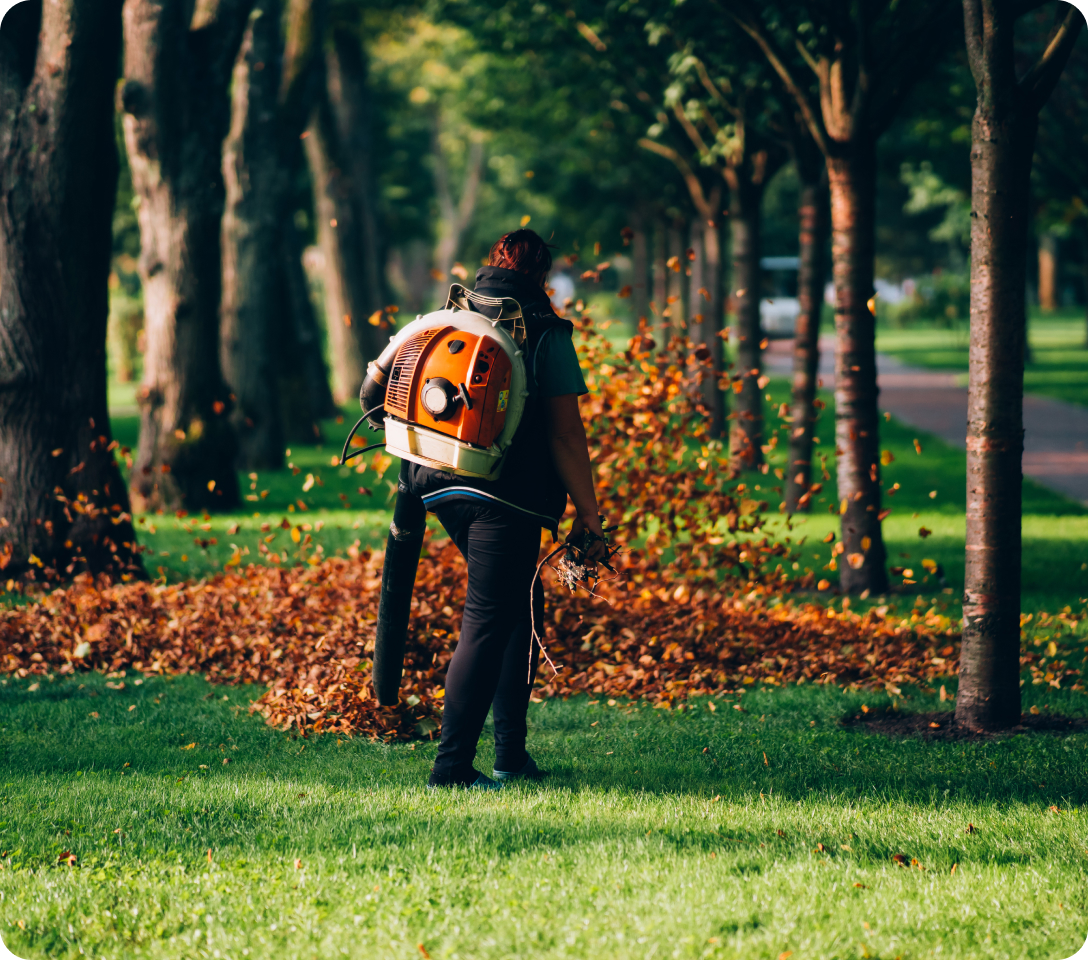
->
xmin=786 ymin=168 xmax=828 ymax=514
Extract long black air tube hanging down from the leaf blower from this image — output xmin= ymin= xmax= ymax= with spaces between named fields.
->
xmin=374 ymin=461 xmax=426 ymax=706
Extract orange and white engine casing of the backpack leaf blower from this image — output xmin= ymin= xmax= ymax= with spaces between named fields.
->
xmin=372 ymin=287 xmax=526 ymax=480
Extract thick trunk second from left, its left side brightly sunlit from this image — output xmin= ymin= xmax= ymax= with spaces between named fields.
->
xmin=121 ymin=0 xmax=252 ymax=510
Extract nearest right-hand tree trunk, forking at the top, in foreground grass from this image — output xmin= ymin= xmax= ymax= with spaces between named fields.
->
xmin=955 ymin=0 xmax=1084 ymax=730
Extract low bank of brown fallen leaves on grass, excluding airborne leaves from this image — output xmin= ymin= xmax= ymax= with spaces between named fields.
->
xmin=0 ymin=541 xmax=970 ymax=739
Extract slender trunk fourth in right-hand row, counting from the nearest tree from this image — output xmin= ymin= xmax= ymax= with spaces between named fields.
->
xmin=729 ymin=179 xmax=763 ymax=473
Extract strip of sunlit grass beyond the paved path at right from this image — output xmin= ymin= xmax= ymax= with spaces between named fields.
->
xmin=877 ymin=308 xmax=1088 ymax=406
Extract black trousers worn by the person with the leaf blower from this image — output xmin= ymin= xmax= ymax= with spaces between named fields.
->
xmin=431 ymin=501 xmax=544 ymax=784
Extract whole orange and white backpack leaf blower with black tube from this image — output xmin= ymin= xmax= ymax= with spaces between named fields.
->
xmin=341 ymin=284 xmax=528 ymax=706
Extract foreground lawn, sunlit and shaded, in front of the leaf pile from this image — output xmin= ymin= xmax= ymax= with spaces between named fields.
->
xmin=0 ymin=675 xmax=1088 ymax=960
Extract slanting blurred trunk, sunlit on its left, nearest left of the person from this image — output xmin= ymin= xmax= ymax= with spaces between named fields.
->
xmin=306 ymin=23 xmax=386 ymax=404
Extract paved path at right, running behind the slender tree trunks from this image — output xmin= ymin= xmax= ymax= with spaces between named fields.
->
xmin=766 ymin=336 xmax=1088 ymax=504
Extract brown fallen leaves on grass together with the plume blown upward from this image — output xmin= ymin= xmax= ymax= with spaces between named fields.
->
xmin=0 ymin=316 xmax=992 ymax=739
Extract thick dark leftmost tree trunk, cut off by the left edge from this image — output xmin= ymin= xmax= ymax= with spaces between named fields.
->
xmin=0 ymin=0 xmax=143 ymax=579
